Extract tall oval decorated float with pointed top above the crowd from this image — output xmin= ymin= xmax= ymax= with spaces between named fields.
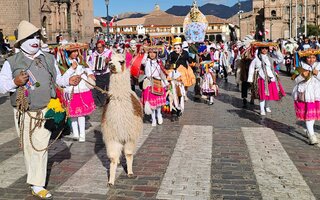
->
xmin=183 ymin=0 xmax=208 ymax=42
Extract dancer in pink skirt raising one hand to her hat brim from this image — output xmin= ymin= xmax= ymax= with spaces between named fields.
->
xmin=248 ymin=42 xmax=286 ymax=115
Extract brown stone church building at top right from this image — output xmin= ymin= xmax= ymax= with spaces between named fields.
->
xmin=230 ymin=0 xmax=320 ymax=40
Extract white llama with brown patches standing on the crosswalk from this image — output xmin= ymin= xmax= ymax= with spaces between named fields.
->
xmin=101 ymin=52 xmax=143 ymax=186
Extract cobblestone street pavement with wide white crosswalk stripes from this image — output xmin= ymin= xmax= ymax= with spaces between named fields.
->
xmin=0 ymin=72 xmax=320 ymax=200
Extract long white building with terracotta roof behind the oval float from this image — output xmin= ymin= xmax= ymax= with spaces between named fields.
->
xmin=110 ymin=5 xmax=229 ymax=40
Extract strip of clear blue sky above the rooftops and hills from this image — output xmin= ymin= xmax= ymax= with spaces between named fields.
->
xmin=93 ymin=0 xmax=237 ymax=16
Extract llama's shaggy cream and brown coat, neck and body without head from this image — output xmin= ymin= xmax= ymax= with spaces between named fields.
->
xmin=101 ymin=70 xmax=143 ymax=147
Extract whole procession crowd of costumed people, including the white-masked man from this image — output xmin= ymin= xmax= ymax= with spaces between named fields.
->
xmin=0 ymin=18 xmax=320 ymax=199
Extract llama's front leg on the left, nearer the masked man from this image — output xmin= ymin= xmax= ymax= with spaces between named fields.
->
xmin=107 ymin=141 xmax=122 ymax=186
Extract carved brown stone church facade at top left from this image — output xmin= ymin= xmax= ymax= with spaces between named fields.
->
xmin=0 ymin=0 xmax=94 ymax=42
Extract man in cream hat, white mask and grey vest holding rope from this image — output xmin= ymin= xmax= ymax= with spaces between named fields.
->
xmin=0 ymin=21 xmax=80 ymax=199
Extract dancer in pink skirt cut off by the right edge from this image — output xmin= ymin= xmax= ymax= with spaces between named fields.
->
xmin=292 ymin=49 xmax=320 ymax=144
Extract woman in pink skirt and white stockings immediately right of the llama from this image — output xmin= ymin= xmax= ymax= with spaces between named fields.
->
xmin=142 ymin=47 xmax=168 ymax=126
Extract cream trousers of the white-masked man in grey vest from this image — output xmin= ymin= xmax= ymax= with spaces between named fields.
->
xmin=13 ymin=109 xmax=51 ymax=186
